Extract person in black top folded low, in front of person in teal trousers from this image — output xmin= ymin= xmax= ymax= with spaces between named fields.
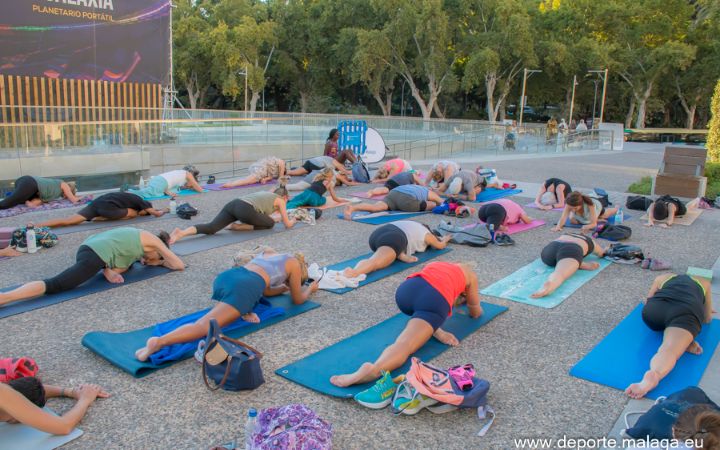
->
xmin=36 ymin=192 xmax=169 ymax=228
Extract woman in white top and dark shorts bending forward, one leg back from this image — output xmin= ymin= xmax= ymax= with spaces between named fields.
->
xmin=343 ymin=220 xmax=452 ymax=278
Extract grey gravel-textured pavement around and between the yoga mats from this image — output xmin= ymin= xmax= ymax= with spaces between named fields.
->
xmin=0 ymin=152 xmax=720 ymax=449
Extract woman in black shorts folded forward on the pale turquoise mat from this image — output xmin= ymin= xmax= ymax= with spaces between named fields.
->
xmin=530 ymin=233 xmax=606 ymax=298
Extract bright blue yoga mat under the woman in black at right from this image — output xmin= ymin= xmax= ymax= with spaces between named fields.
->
xmin=570 ymin=305 xmax=720 ymax=399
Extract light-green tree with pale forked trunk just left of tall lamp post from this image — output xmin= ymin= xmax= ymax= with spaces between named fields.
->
xmin=461 ymin=0 xmax=538 ymax=122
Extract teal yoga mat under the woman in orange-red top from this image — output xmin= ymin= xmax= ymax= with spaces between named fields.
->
xmin=275 ymin=302 xmax=507 ymax=398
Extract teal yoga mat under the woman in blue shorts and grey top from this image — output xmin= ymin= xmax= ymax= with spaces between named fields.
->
xmin=82 ymin=295 xmax=320 ymax=378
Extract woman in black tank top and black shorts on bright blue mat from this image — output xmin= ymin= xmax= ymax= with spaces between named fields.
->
xmin=625 ymin=273 xmax=713 ymax=398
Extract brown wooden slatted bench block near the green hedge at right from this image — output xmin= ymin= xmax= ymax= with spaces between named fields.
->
xmin=652 ymin=145 xmax=707 ymax=198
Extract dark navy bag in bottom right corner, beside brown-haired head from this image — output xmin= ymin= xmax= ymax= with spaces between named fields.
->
xmin=624 ymin=386 xmax=720 ymax=440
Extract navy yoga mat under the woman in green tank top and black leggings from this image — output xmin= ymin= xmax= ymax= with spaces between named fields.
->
xmin=0 ymin=263 xmax=170 ymax=319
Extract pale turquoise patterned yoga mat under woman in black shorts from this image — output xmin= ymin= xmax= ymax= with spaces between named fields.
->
xmin=480 ymin=255 xmax=611 ymax=308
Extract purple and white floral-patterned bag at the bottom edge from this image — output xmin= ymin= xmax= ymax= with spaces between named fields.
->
xmin=250 ymin=404 xmax=333 ymax=450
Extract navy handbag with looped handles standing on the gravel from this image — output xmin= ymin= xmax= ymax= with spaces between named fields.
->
xmin=202 ymin=319 xmax=265 ymax=391
